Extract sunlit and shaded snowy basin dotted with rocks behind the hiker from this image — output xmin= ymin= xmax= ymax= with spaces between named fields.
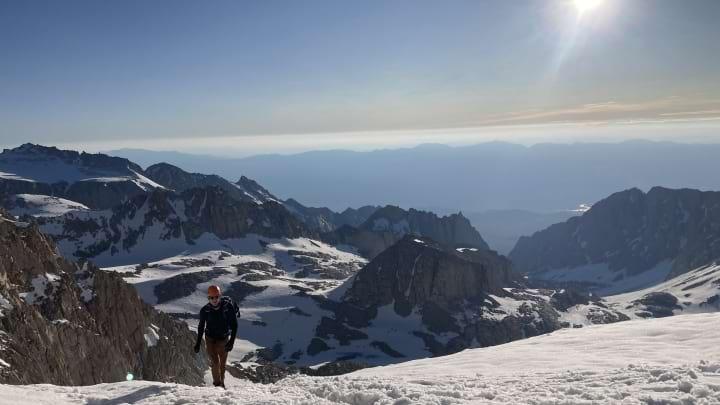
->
xmin=104 ymin=235 xmax=367 ymax=363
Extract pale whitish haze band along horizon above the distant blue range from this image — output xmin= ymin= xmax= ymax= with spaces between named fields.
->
xmin=0 ymin=124 xmax=720 ymax=158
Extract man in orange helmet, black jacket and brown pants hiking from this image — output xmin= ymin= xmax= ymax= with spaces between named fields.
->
xmin=195 ymin=285 xmax=237 ymax=388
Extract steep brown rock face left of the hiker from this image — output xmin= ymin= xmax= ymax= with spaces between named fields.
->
xmin=0 ymin=210 xmax=207 ymax=385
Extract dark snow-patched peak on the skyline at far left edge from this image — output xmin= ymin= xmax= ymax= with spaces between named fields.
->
xmin=0 ymin=143 xmax=158 ymax=209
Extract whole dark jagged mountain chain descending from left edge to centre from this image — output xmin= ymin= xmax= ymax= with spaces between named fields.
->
xmin=0 ymin=144 xmax=488 ymax=266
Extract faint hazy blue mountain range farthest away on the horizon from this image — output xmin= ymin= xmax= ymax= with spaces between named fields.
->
xmin=112 ymin=141 xmax=720 ymax=213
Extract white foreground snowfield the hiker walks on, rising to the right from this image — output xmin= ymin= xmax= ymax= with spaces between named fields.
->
xmin=0 ymin=313 xmax=720 ymax=405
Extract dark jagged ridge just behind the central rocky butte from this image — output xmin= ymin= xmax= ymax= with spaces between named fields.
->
xmin=323 ymin=205 xmax=489 ymax=258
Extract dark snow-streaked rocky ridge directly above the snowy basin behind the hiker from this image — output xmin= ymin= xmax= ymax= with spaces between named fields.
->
xmin=35 ymin=187 xmax=313 ymax=262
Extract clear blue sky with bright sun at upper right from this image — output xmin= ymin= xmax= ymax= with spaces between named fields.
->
xmin=0 ymin=0 xmax=720 ymax=155
